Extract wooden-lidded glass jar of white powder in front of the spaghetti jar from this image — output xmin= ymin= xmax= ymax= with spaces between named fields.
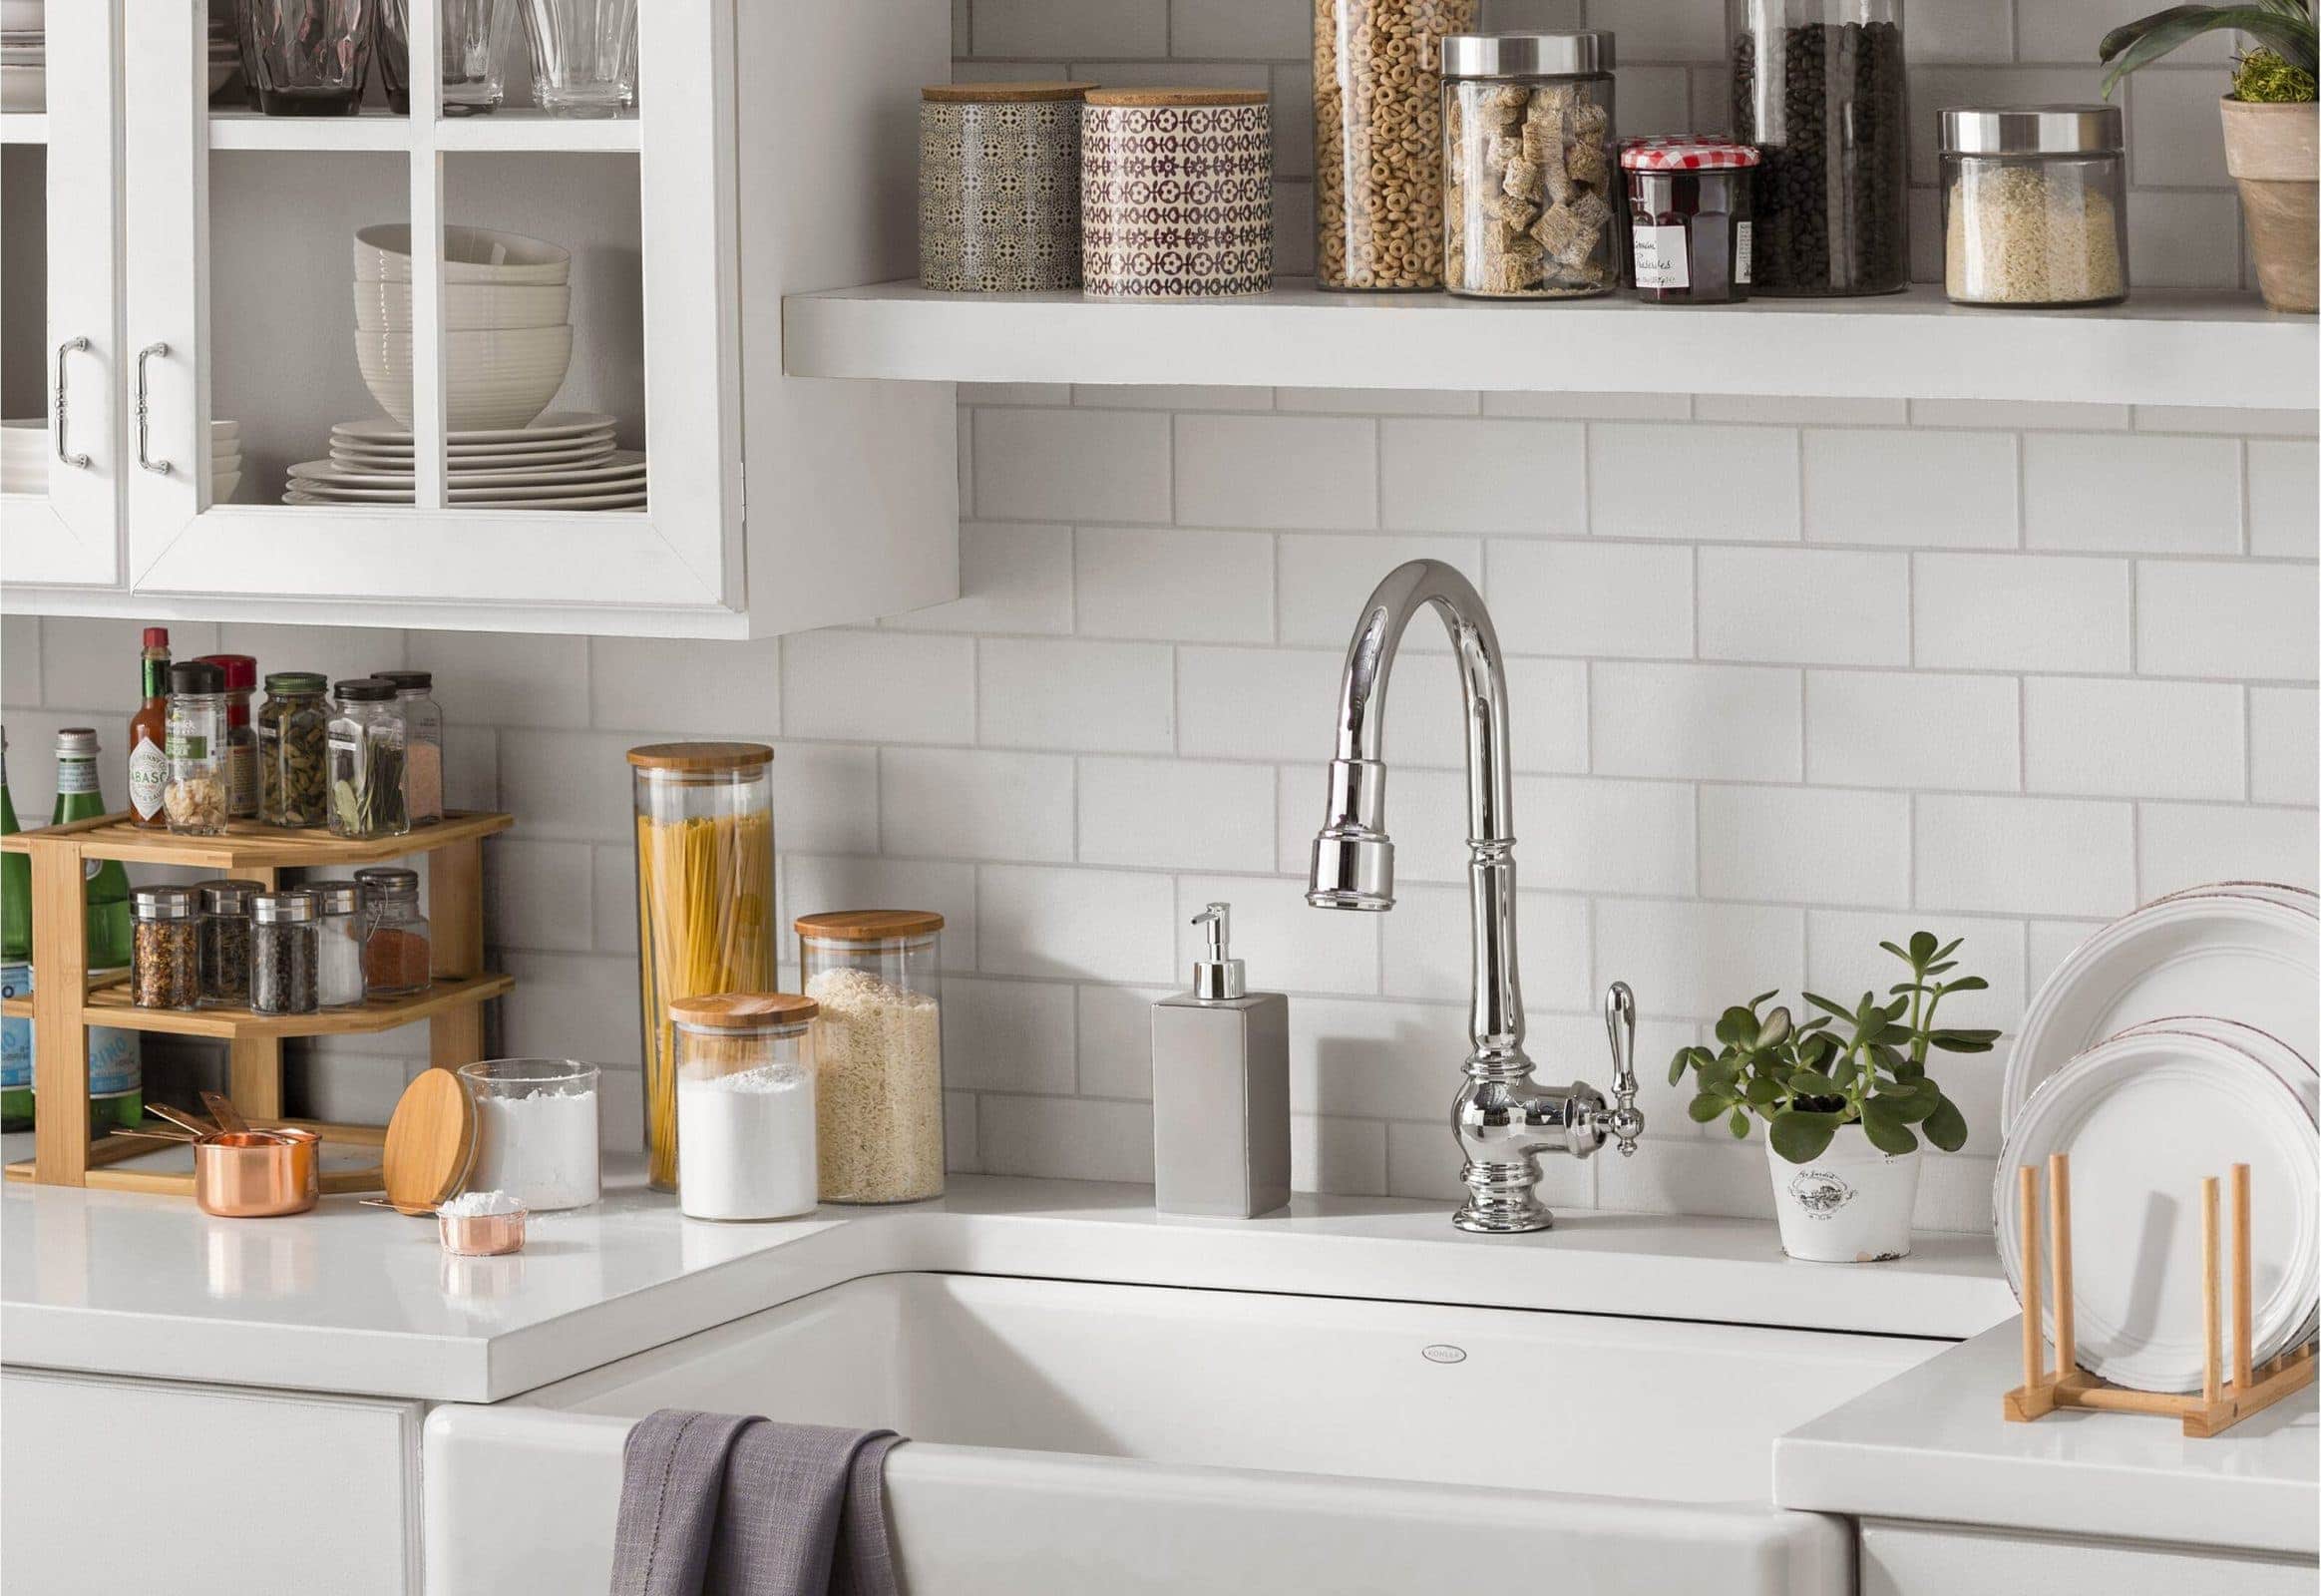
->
xmin=668 ymin=993 xmax=819 ymax=1220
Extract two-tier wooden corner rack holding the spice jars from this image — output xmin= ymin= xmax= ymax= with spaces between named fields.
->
xmin=0 ymin=810 xmax=516 ymax=1197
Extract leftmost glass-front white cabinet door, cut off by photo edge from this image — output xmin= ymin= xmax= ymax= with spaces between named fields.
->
xmin=0 ymin=0 xmax=123 ymax=590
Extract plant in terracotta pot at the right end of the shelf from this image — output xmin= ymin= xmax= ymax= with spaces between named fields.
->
xmin=2096 ymin=0 xmax=2316 ymax=313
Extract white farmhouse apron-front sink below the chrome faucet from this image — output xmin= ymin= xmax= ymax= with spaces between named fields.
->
xmin=425 ymin=1274 xmax=1947 ymax=1596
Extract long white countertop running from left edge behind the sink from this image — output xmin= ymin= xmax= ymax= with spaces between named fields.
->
xmin=0 ymin=1160 xmax=2015 ymax=1403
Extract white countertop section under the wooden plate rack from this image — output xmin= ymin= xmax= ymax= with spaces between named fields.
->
xmin=1773 ymin=1316 xmax=2321 ymax=1556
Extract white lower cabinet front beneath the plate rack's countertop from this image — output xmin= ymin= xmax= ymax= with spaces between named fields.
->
xmin=1859 ymin=1512 xmax=2316 ymax=1596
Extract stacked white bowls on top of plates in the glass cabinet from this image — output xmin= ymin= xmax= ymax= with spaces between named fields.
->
xmin=355 ymin=222 xmax=574 ymax=432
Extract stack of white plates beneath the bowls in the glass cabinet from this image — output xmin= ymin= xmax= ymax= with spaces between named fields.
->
xmin=283 ymin=413 xmax=645 ymax=511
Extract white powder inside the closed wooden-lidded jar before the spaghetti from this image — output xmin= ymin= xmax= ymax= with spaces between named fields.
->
xmin=677 ymin=1062 xmax=817 ymax=1220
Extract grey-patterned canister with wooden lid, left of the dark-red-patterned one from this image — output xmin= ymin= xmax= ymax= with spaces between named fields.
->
xmin=919 ymin=84 xmax=1091 ymax=294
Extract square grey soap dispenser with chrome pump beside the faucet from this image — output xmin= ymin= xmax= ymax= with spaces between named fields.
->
xmin=1154 ymin=903 xmax=1291 ymax=1220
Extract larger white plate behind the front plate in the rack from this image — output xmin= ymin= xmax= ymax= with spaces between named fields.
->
xmin=1999 ymin=889 xmax=2321 ymax=1127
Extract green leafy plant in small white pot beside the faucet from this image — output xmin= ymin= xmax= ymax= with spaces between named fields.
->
xmin=1669 ymin=931 xmax=1999 ymax=1264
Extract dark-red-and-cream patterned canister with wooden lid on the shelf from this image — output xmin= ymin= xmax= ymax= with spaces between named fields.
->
xmin=1079 ymin=88 xmax=1275 ymax=299
